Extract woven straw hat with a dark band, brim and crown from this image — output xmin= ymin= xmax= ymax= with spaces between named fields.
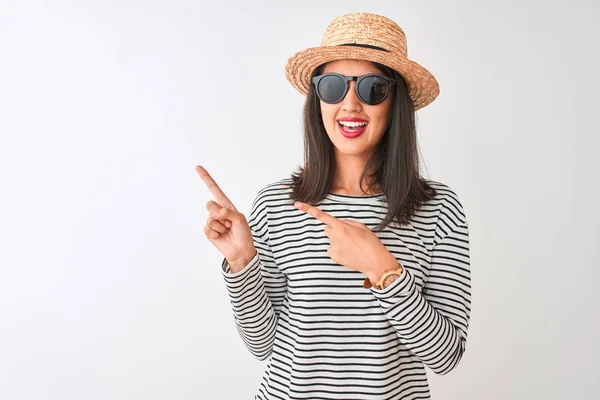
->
xmin=285 ymin=12 xmax=440 ymax=110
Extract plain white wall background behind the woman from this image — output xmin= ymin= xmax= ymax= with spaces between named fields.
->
xmin=0 ymin=0 xmax=600 ymax=400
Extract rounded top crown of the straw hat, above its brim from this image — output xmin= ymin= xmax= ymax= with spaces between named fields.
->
xmin=321 ymin=12 xmax=408 ymax=58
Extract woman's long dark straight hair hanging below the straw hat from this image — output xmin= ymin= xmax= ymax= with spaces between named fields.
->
xmin=290 ymin=62 xmax=436 ymax=230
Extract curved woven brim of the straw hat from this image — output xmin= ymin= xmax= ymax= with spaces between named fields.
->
xmin=285 ymin=46 xmax=440 ymax=111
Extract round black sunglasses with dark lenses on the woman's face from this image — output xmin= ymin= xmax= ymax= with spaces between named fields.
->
xmin=312 ymin=72 xmax=396 ymax=106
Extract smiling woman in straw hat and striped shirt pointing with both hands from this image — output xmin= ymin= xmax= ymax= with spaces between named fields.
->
xmin=197 ymin=13 xmax=471 ymax=399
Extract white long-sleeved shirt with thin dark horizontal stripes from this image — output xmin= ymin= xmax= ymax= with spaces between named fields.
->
xmin=222 ymin=178 xmax=471 ymax=400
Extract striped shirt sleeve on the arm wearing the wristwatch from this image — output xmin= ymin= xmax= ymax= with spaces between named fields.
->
xmin=371 ymin=197 xmax=471 ymax=375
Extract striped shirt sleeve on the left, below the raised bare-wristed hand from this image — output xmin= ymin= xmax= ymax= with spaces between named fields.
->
xmin=221 ymin=189 xmax=287 ymax=360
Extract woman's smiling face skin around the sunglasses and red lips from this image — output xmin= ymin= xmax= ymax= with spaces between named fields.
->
xmin=320 ymin=60 xmax=393 ymax=159
